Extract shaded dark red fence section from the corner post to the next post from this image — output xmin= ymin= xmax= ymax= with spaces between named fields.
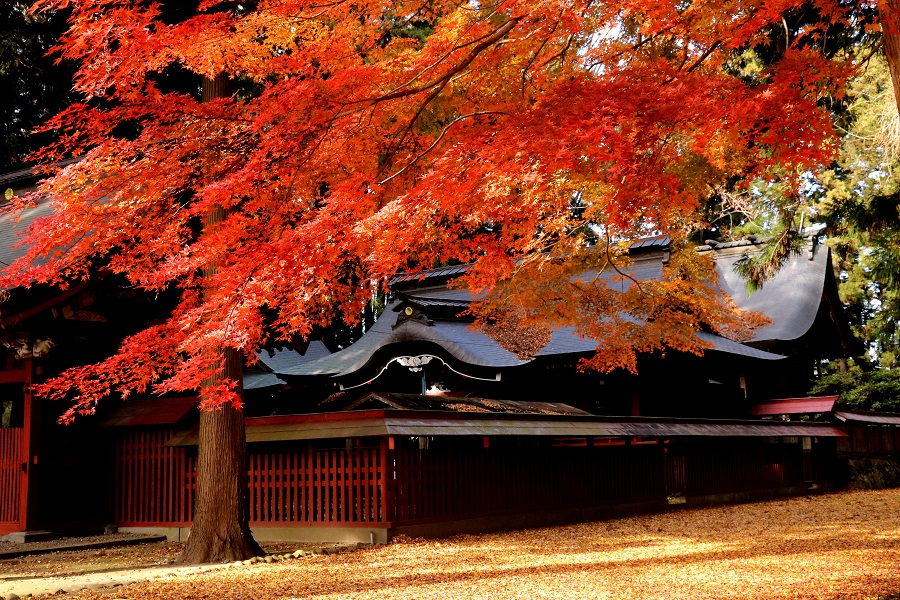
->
xmin=388 ymin=438 xmax=662 ymax=525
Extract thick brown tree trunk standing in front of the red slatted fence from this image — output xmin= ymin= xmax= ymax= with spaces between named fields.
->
xmin=179 ymin=74 xmax=262 ymax=564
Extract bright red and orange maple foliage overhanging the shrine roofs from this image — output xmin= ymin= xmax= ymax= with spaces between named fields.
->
xmin=0 ymin=0 xmax=854 ymax=560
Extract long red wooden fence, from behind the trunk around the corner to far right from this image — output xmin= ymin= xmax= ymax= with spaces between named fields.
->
xmin=115 ymin=430 xmax=815 ymax=527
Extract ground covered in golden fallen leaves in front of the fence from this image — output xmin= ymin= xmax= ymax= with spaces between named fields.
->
xmin=38 ymin=490 xmax=900 ymax=600
